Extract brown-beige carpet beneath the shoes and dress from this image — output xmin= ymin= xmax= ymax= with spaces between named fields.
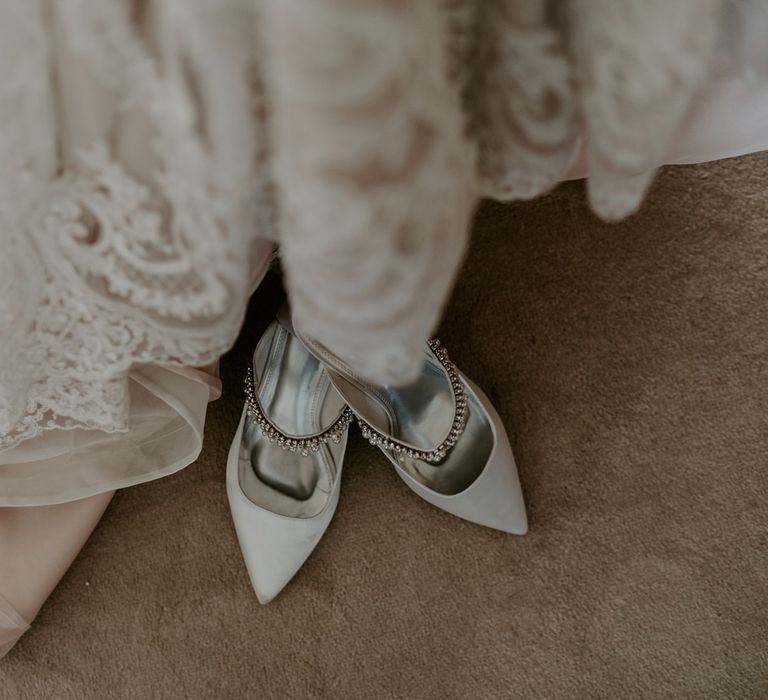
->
xmin=0 ymin=155 xmax=768 ymax=700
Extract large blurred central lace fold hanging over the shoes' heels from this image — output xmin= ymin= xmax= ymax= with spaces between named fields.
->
xmin=263 ymin=0 xmax=474 ymax=381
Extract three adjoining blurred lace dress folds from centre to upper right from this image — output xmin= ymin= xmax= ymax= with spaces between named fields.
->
xmin=263 ymin=0 xmax=736 ymax=382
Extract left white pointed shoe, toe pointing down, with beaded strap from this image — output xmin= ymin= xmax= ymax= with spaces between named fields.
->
xmin=227 ymin=321 xmax=352 ymax=604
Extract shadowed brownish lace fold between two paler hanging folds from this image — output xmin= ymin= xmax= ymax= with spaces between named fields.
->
xmin=467 ymin=0 xmax=580 ymax=199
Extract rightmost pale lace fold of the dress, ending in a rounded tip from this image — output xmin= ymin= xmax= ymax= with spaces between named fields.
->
xmin=570 ymin=0 xmax=723 ymax=219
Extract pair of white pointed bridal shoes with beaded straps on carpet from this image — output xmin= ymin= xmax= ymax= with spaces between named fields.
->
xmin=227 ymin=308 xmax=527 ymax=604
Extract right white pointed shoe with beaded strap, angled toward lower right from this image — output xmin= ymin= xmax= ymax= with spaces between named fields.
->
xmin=304 ymin=339 xmax=528 ymax=535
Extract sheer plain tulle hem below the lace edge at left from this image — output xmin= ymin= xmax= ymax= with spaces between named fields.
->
xmin=0 ymin=365 xmax=221 ymax=506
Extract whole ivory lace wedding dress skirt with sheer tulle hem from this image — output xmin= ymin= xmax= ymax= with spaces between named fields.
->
xmin=0 ymin=0 xmax=768 ymax=505
